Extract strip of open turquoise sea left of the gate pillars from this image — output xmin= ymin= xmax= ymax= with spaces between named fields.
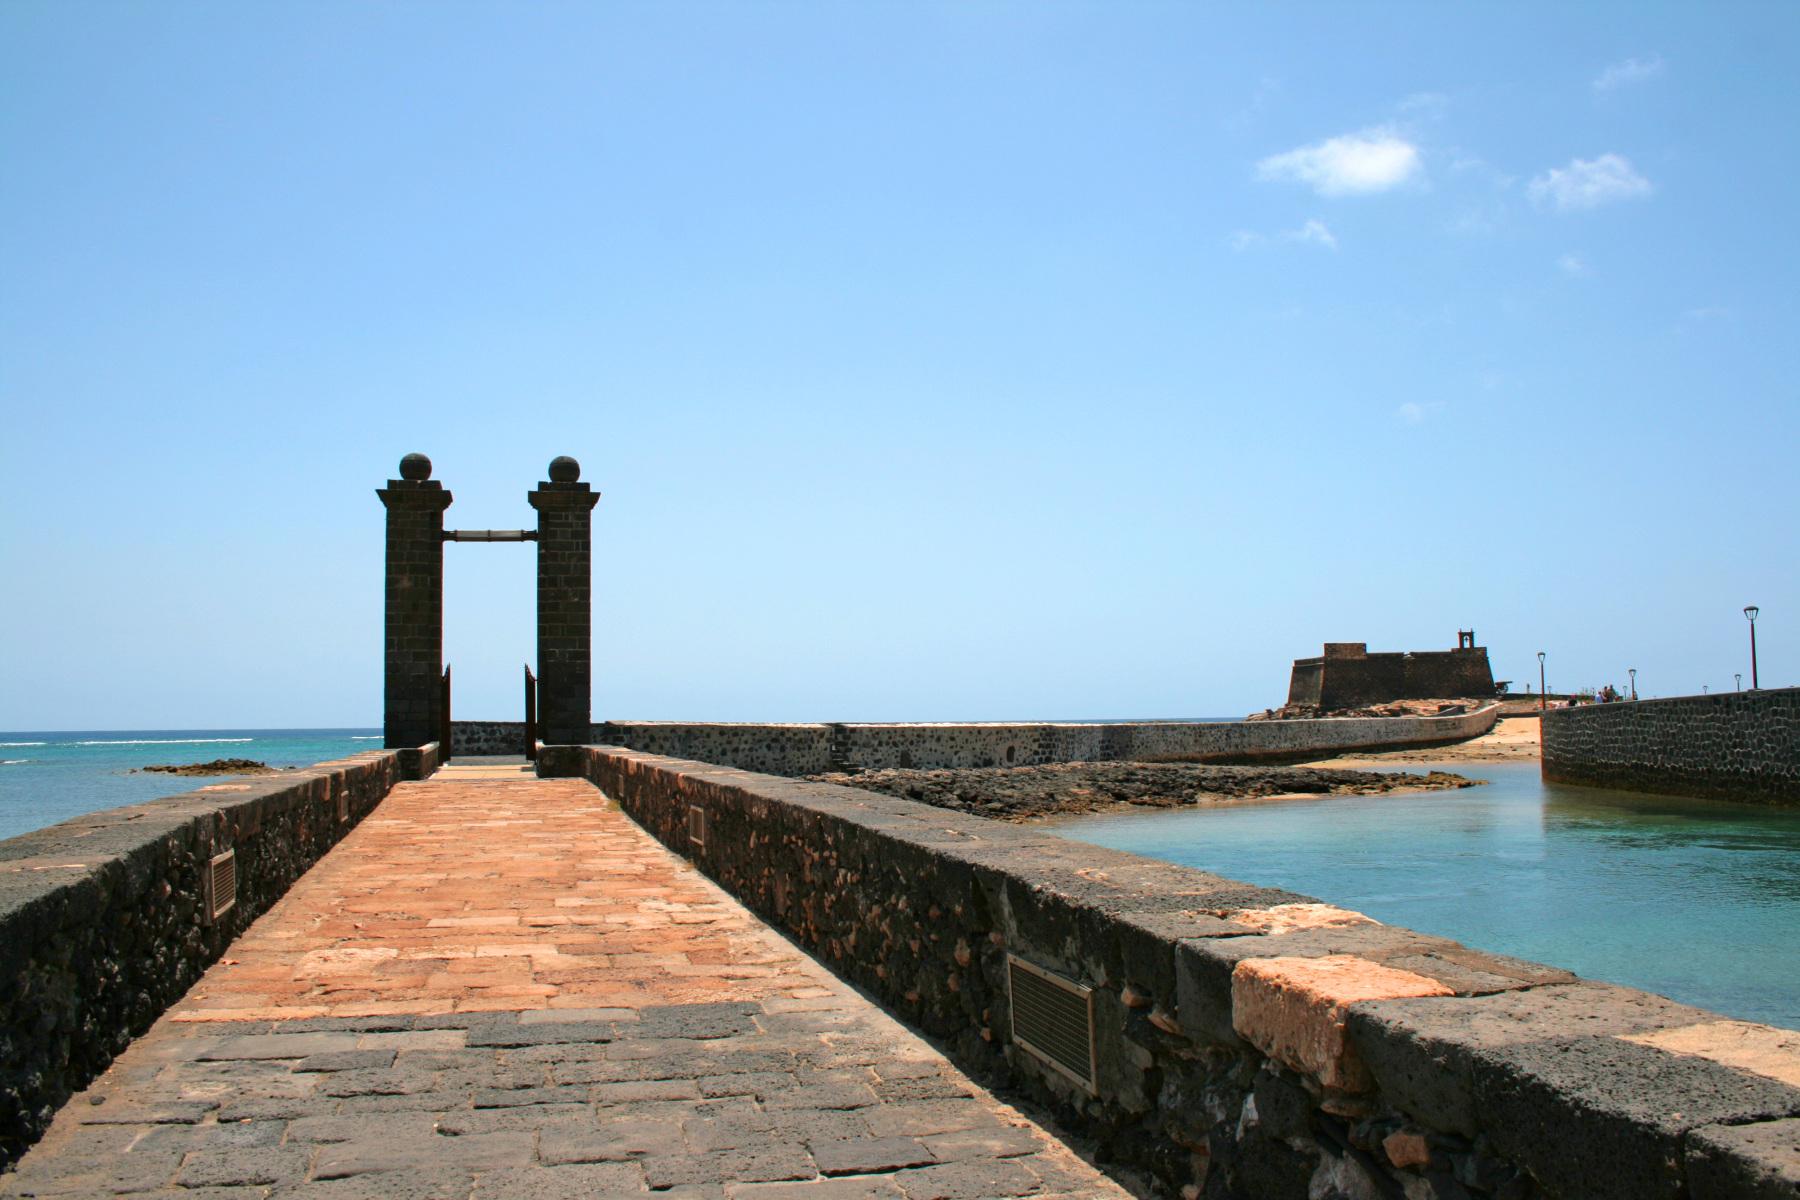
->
xmin=0 ymin=729 xmax=382 ymax=838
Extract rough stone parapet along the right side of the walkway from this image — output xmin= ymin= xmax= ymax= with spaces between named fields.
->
xmin=538 ymin=747 xmax=1800 ymax=1200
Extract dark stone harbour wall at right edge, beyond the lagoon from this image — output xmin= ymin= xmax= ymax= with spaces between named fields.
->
xmin=1543 ymin=687 xmax=1800 ymax=804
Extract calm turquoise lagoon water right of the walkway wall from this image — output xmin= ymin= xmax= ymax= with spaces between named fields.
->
xmin=1053 ymin=763 xmax=1800 ymax=1029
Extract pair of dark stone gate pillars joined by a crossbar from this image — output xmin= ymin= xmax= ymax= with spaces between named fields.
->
xmin=374 ymin=453 xmax=599 ymax=748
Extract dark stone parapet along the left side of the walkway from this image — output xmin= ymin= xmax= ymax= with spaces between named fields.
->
xmin=0 ymin=743 xmax=437 ymax=1168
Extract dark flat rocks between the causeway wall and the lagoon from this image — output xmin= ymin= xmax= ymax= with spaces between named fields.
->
xmin=806 ymin=763 xmax=1478 ymax=822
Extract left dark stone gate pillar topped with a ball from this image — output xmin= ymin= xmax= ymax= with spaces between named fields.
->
xmin=374 ymin=453 xmax=450 ymax=748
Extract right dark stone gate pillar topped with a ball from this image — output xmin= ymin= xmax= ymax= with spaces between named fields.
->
xmin=527 ymin=455 xmax=599 ymax=745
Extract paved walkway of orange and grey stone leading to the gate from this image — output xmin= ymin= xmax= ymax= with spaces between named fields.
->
xmin=0 ymin=765 xmax=1127 ymax=1200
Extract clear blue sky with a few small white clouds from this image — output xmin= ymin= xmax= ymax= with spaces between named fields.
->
xmin=0 ymin=0 xmax=1800 ymax=729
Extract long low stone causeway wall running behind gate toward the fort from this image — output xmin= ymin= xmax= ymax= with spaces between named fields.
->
xmin=450 ymin=705 xmax=1499 ymax=775
